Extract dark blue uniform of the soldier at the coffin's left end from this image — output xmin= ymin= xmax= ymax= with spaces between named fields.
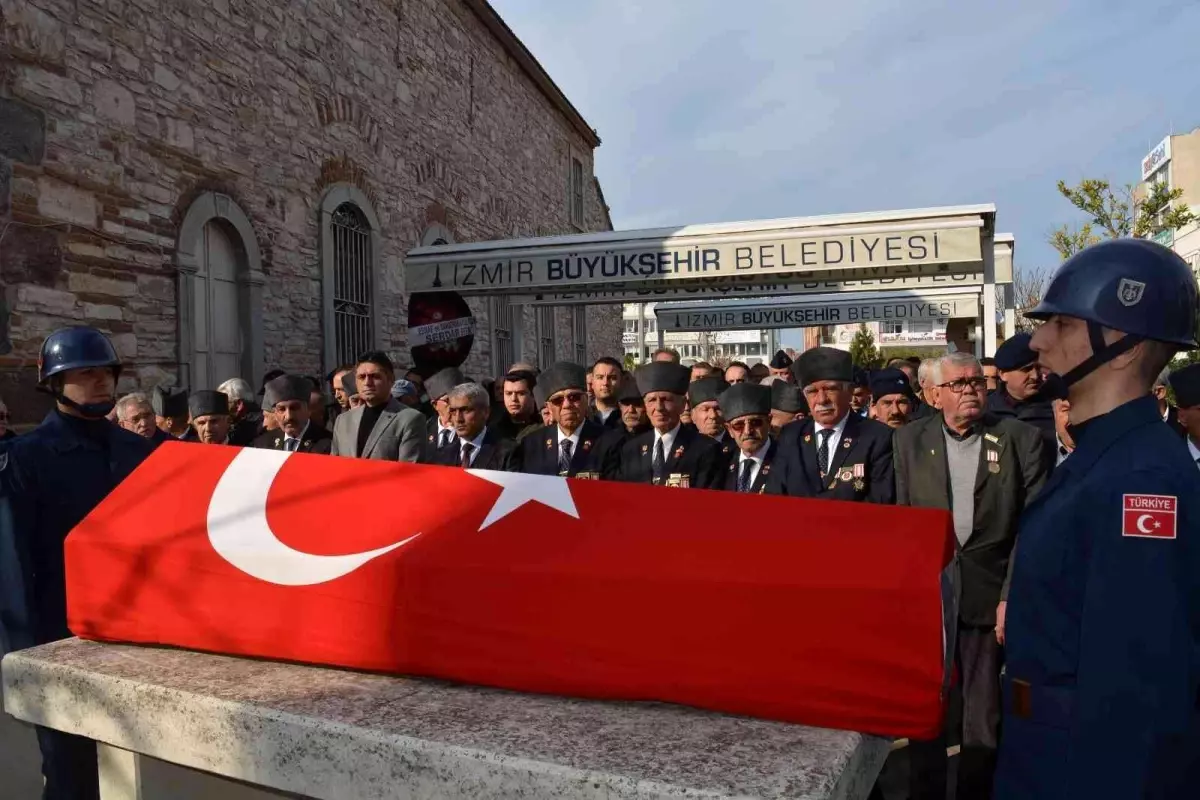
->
xmin=0 ymin=411 xmax=154 ymax=800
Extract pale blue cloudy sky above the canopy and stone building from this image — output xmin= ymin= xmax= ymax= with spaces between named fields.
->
xmin=492 ymin=0 xmax=1200 ymax=275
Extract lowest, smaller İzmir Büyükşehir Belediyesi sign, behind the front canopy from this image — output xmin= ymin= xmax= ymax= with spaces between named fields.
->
xmin=655 ymin=294 xmax=979 ymax=331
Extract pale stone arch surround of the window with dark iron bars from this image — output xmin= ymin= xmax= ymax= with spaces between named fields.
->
xmin=319 ymin=182 xmax=383 ymax=372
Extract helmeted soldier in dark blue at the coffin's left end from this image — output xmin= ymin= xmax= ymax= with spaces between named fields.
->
xmin=0 ymin=326 xmax=154 ymax=800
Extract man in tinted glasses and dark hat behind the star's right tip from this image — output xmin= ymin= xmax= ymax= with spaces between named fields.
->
xmin=514 ymin=361 xmax=613 ymax=480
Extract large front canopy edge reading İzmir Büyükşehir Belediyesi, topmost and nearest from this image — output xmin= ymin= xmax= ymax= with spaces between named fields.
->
xmin=404 ymin=205 xmax=996 ymax=295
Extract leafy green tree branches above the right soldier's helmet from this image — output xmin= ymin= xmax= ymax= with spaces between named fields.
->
xmin=1049 ymin=178 xmax=1196 ymax=259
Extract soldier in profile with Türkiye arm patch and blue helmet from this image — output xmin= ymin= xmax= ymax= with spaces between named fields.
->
xmin=995 ymin=239 xmax=1200 ymax=800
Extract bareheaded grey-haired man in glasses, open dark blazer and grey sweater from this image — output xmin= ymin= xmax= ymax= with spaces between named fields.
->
xmin=894 ymin=353 xmax=1049 ymax=800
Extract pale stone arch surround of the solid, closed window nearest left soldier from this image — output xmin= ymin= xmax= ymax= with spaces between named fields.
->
xmin=175 ymin=191 xmax=266 ymax=391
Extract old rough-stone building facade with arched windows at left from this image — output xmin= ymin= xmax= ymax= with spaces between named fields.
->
xmin=0 ymin=0 xmax=622 ymax=421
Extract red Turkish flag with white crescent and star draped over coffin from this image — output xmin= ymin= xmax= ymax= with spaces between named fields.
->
xmin=66 ymin=443 xmax=953 ymax=738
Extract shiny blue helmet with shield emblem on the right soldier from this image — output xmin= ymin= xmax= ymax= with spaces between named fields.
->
xmin=1026 ymin=239 xmax=1200 ymax=349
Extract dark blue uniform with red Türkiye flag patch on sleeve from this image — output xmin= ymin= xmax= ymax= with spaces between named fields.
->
xmin=995 ymin=396 xmax=1200 ymax=800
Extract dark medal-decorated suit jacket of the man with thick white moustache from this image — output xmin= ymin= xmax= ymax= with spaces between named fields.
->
xmin=767 ymin=411 xmax=895 ymax=504
